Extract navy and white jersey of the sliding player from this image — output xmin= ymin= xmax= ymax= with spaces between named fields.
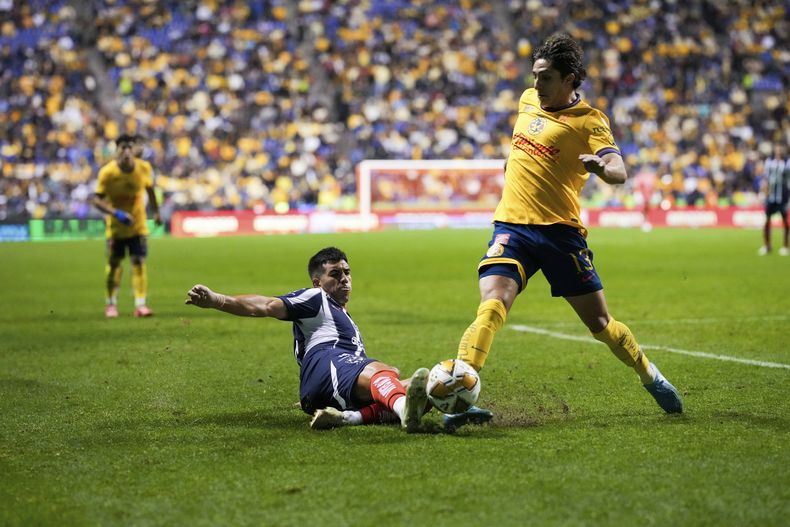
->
xmin=278 ymin=287 xmax=366 ymax=366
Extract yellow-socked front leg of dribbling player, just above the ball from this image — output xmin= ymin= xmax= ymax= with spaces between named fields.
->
xmin=457 ymin=275 xmax=519 ymax=371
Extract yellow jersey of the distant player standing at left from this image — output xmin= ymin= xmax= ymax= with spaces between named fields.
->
xmin=96 ymin=159 xmax=154 ymax=239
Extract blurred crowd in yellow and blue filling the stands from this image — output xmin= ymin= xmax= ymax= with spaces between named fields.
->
xmin=0 ymin=0 xmax=790 ymax=220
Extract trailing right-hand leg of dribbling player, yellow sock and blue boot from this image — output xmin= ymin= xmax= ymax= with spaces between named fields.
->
xmin=565 ymin=290 xmax=683 ymax=413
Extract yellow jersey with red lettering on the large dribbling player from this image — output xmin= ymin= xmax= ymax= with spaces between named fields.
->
xmin=494 ymin=88 xmax=620 ymax=235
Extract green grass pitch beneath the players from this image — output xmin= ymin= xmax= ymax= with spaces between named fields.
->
xmin=0 ymin=229 xmax=790 ymax=526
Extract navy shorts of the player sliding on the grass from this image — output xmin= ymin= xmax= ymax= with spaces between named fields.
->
xmin=299 ymin=348 xmax=377 ymax=415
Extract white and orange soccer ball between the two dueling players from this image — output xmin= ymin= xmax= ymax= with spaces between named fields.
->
xmin=428 ymin=359 xmax=480 ymax=414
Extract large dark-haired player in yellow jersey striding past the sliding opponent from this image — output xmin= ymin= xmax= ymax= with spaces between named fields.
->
xmin=458 ymin=34 xmax=683 ymax=413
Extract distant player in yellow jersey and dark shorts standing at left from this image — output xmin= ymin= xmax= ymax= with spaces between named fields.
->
xmin=93 ymin=135 xmax=162 ymax=318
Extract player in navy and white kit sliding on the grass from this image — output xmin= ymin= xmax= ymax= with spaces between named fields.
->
xmin=186 ymin=247 xmax=491 ymax=432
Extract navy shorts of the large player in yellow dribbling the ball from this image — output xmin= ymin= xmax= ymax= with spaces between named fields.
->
xmin=477 ymin=221 xmax=603 ymax=296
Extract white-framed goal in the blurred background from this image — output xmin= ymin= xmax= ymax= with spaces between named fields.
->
xmin=357 ymin=159 xmax=505 ymax=217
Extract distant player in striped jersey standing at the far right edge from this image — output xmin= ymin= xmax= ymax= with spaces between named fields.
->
xmin=759 ymin=145 xmax=790 ymax=256
